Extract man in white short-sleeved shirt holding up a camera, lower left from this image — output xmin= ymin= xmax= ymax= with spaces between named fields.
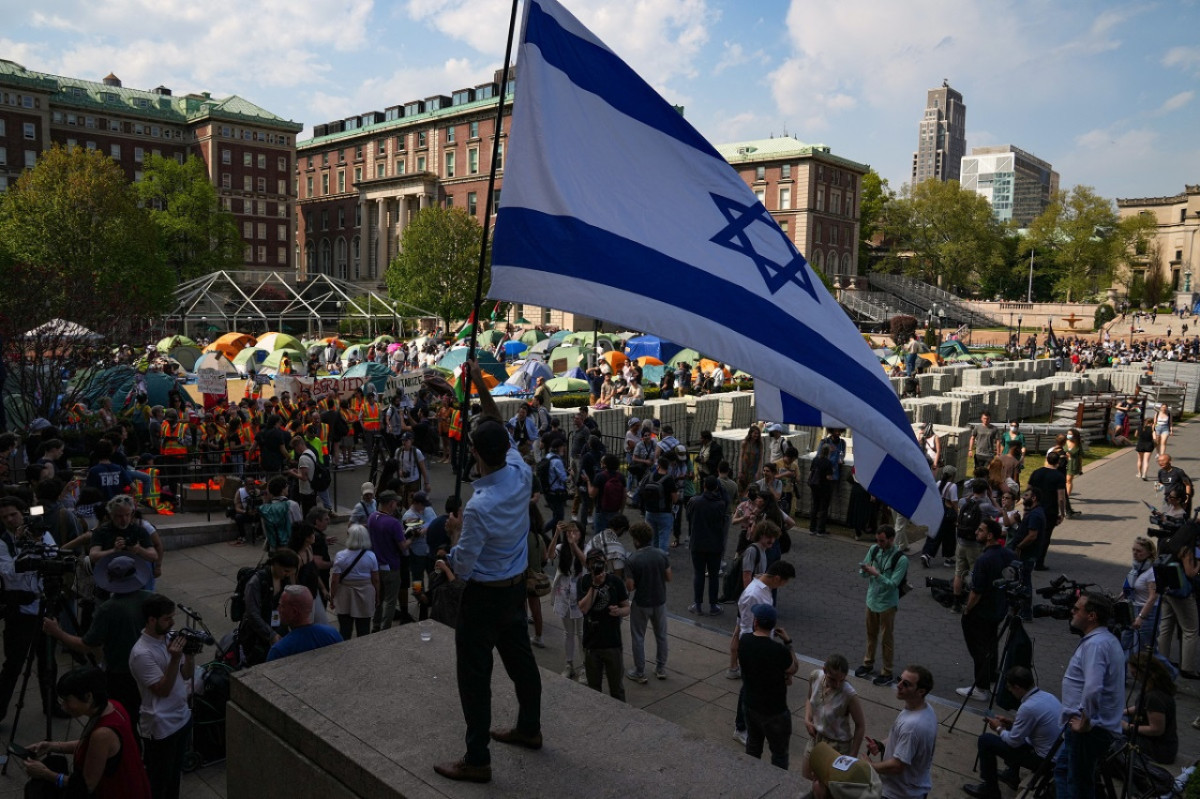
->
xmin=130 ymin=594 xmax=196 ymax=799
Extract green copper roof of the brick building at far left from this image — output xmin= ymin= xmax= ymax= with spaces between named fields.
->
xmin=0 ymin=60 xmax=304 ymax=132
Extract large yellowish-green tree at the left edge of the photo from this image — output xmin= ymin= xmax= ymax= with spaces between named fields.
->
xmin=0 ymin=146 xmax=173 ymax=421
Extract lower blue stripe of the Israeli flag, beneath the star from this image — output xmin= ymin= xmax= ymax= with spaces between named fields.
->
xmin=492 ymin=206 xmax=912 ymax=438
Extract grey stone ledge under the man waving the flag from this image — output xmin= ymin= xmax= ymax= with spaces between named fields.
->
xmin=228 ymin=625 xmax=806 ymax=799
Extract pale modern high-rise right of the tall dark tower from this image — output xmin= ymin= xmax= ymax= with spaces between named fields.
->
xmin=960 ymin=144 xmax=1058 ymax=228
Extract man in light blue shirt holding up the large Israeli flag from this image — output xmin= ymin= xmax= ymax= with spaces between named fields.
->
xmin=434 ymin=360 xmax=542 ymax=782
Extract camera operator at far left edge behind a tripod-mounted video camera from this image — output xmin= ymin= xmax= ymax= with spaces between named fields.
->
xmin=0 ymin=497 xmax=66 ymax=720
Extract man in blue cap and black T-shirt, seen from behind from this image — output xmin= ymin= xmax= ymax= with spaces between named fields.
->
xmin=738 ymin=602 xmax=800 ymax=770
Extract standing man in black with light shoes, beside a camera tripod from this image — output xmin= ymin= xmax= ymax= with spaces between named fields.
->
xmin=955 ymin=518 xmax=1016 ymax=702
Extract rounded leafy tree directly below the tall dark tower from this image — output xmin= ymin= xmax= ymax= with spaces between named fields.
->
xmin=883 ymin=180 xmax=1003 ymax=288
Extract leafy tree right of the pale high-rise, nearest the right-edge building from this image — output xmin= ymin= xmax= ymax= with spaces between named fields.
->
xmin=1025 ymin=186 xmax=1144 ymax=302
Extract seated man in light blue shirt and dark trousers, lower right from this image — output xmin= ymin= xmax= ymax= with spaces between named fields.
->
xmin=962 ymin=666 xmax=1062 ymax=799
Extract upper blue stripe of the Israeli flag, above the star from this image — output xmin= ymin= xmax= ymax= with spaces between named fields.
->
xmin=524 ymin=0 xmax=724 ymax=161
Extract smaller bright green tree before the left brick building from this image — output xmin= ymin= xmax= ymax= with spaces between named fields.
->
xmin=134 ymin=155 xmax=244 ymax=282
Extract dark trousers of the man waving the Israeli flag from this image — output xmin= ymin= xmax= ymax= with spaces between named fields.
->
xmin=454 ymin=581 xmax=541 ymax=765
